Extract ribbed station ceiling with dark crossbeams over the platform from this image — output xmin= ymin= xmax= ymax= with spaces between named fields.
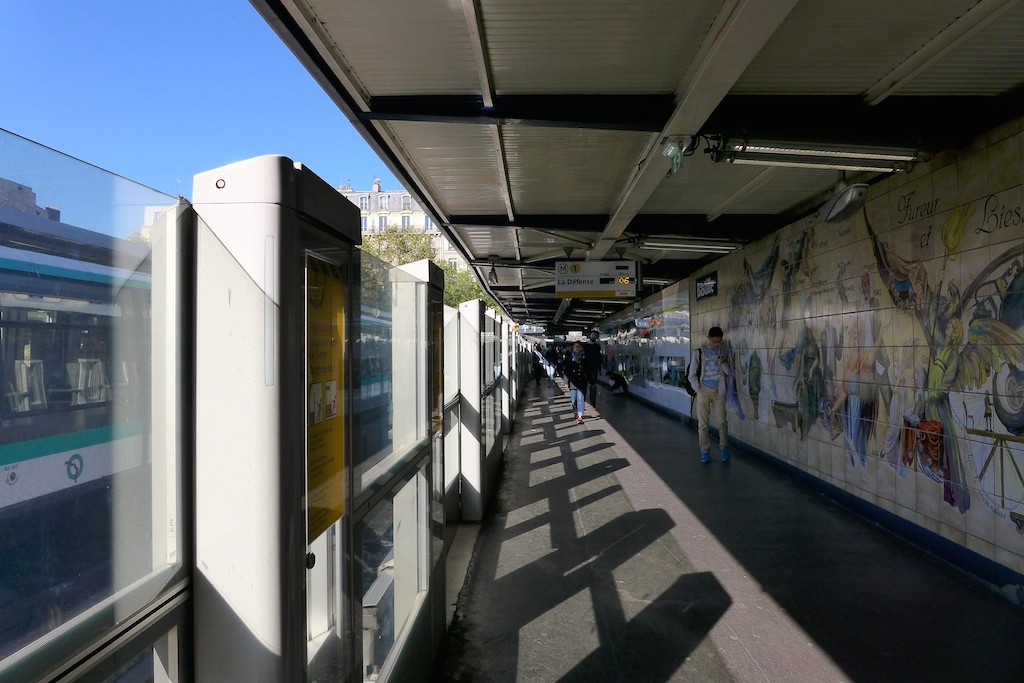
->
xmin=252 ymin=0 xmax=1024 ymax=334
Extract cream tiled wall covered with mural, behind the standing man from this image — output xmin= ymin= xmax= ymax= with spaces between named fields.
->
xmin=691 ymin=120 xmax=1024 ymax=602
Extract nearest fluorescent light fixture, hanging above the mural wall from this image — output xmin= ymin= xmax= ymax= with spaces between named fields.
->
xmin=712 ymin=140 xmax=922 ymax=173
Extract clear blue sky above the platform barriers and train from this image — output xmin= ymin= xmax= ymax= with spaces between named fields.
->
xmin=0 ymin=0 xmax=400 ymax=198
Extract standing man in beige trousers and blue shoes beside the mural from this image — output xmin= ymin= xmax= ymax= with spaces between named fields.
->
xmin=689 ymin=326 xmax=732 ymax=463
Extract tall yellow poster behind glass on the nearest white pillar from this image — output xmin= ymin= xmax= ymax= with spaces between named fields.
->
xmin=306 ymin=258 xmax=345 ymax=541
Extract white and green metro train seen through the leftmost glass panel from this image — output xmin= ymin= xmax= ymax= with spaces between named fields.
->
xmin=0 ymin=216 xmax=153 ymax=658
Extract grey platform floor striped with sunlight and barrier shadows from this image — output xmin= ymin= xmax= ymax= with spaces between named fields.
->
xmin=434 ymin=381 xmax=1024 ymax=683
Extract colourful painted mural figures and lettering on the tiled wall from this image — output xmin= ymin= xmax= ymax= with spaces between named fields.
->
xmin=716 ymin=160 xmax=1024 ymax=533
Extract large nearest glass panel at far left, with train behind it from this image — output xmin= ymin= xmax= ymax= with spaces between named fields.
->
xmin=0 ymin=126 xmax=184 ymax=680
